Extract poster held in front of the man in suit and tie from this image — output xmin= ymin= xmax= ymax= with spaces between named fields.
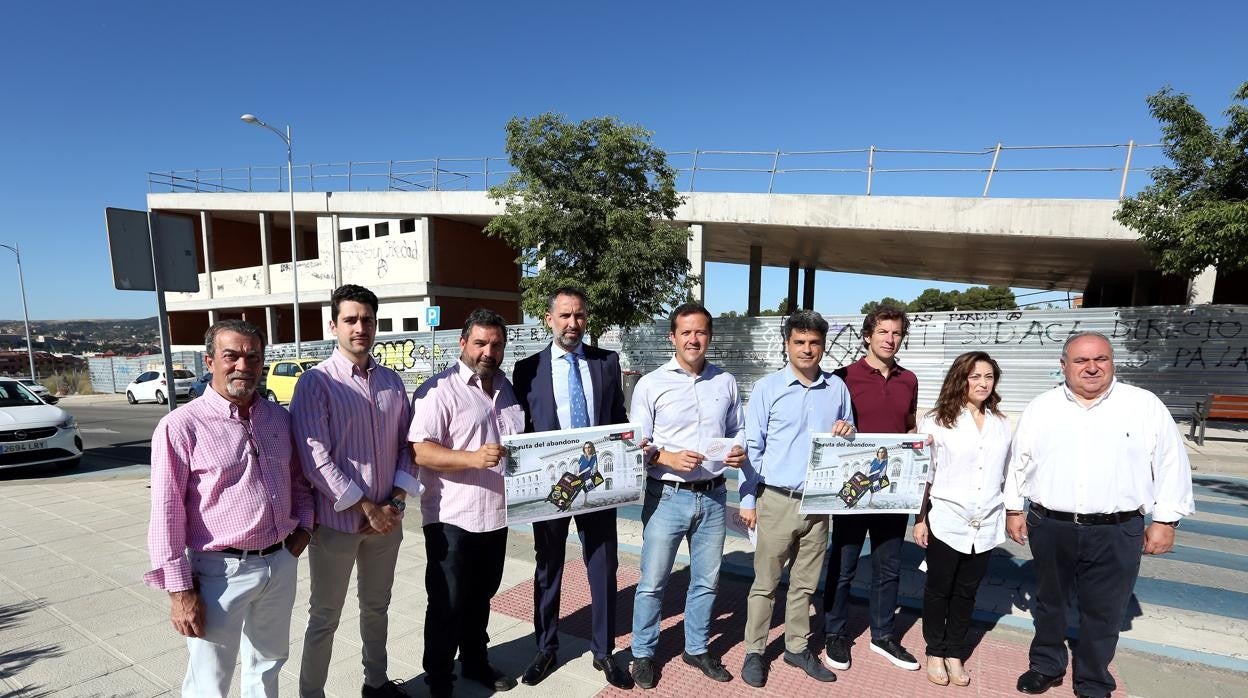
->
xmin=503 ymin=425 xmax=645 ymax=526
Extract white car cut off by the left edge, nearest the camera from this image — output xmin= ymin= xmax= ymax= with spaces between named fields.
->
xmin=0 ymin=378 xmax=82 ymax=468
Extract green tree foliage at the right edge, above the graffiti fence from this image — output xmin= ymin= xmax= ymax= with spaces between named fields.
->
xmin=1114 ymin=82 xmax=1248 ymax=277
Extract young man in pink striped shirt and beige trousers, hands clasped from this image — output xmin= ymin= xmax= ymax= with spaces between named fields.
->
xmin=291 ymin=283 xmax=419 ymax=698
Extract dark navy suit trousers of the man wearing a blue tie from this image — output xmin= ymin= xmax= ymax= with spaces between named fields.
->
xmin=533 ymin=509 xmax=619 ymax=659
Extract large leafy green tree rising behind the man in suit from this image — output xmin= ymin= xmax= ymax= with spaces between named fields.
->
xmin=485 ymin=114 xmax=698 ymax=343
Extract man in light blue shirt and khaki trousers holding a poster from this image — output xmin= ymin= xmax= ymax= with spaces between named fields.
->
xmin=740 ymin=310 xmax=854 ymax=688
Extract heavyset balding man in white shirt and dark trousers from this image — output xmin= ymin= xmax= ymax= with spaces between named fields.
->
xmin=1005 ymin=332 xmax=1194 ymax=696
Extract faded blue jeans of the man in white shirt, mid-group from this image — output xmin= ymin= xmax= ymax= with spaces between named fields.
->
xmin=633 ymin=478 xmax=728 ymax=657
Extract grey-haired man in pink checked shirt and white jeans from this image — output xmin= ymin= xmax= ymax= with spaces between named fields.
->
xmin=144 ymin=320 xmax=312 ymax=697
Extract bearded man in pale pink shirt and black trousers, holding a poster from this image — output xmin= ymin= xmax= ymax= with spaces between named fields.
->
xmin=408 ymin=308 xmax=524 ymax=698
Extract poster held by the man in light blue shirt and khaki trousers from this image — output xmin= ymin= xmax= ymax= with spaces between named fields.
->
xmin=801 ymin=433 xmax=931 ymax=514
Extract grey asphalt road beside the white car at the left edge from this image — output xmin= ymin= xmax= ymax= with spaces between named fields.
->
xmin=0 ymin=396 xmax=168 ymax=484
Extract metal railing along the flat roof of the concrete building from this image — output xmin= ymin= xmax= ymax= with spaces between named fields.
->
xmin=147 ymin=141 xmax=1162 ymax=199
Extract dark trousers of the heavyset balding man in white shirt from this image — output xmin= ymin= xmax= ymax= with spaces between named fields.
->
xmin=1027 ymin=509 xmax=1144 ymax=696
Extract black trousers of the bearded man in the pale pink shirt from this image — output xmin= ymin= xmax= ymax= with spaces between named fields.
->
xmin=423 ymin=523 xmax=507 ymax=686
